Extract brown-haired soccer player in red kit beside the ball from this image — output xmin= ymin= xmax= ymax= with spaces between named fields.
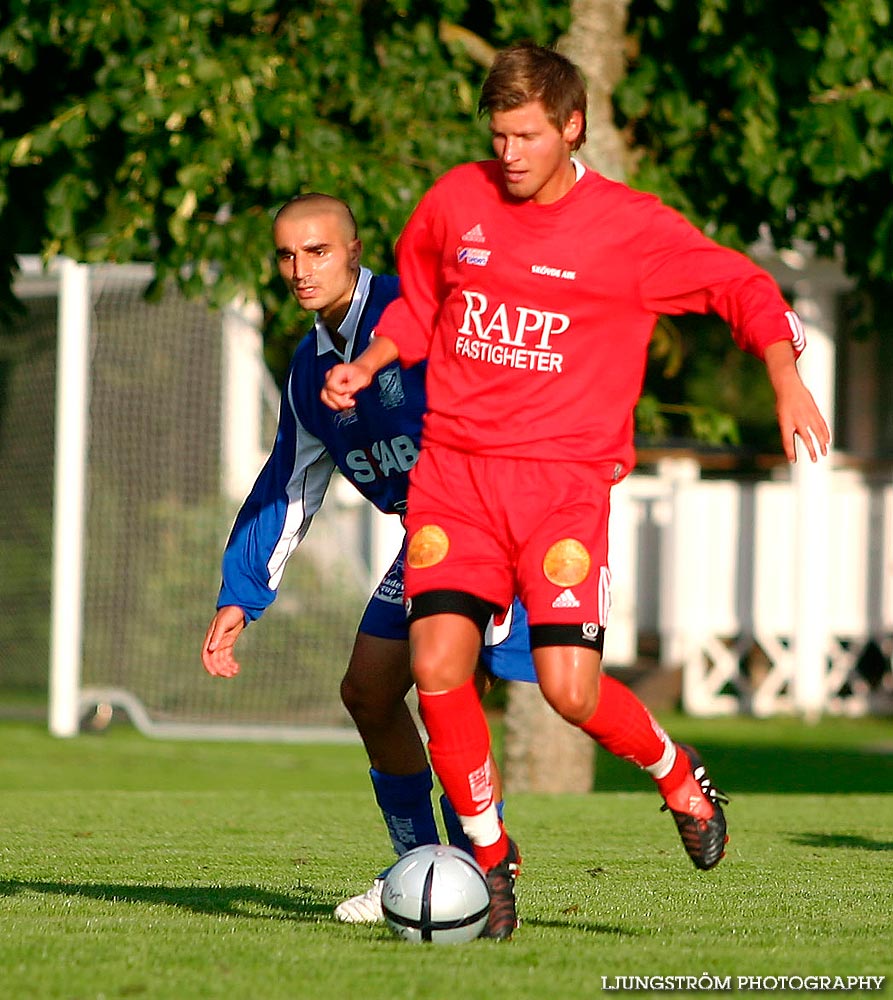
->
xmin=323 ymin=45 xmax=830 ymax=939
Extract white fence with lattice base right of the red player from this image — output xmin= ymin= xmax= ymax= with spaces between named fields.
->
xmin=592 ymin=459 xmax=893 ymax=716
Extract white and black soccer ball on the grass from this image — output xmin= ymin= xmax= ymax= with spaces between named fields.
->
xmin=381 ymin=844 xmax=490 ymax=944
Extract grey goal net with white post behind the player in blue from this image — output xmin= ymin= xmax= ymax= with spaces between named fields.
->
xmin=0 ymin=256 xmax=394 ymax=739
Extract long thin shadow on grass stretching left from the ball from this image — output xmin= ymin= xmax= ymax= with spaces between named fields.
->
xmin=0 ymin=879 xmax=334 ymax=923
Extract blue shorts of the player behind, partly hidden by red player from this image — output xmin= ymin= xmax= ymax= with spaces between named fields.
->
xmin=359 ymin=542 xmax=536 ymax=684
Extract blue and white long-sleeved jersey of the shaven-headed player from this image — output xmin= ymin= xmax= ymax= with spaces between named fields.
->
xmin=217 ymin=268 xmax=425 ymax=621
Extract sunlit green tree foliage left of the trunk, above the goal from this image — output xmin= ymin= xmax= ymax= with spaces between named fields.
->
xmin=0 ymin=0 xmax=567 ymax=352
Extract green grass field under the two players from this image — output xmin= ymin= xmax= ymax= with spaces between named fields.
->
xmin=0 ymin=717 xmax=893 ymax=1000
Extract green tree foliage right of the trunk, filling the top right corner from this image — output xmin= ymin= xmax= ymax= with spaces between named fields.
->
xmin=615 ymin=0 xmax=893 ymax=285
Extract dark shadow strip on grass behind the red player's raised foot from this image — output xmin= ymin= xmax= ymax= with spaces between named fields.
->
xmin=595 ymin=740 xmax=893 ymax=796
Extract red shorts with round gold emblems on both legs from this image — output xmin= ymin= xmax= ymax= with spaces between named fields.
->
xmin=405 ymin=446 xmax=614 ymax=626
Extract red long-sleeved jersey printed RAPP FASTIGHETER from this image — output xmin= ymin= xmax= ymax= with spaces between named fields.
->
xmin=376 ymin=161 xmax=804 ymax=473
